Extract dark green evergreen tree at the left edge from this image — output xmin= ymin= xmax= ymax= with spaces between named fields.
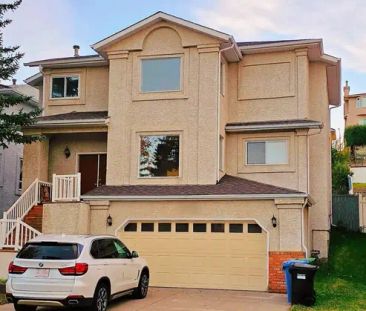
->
xmin=0 ymin=0 xmax=42 ymax=148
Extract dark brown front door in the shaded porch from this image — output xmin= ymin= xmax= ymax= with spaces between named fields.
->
xmin=79 ymin=154 xmax=107 ymax=194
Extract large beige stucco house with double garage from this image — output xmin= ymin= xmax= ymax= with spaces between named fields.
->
xmin=1 ymin=12 xmax=340 ymax=292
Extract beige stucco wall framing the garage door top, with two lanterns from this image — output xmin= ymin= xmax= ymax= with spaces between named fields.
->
xmin=43 ymin=200 xmax=303 ymax=251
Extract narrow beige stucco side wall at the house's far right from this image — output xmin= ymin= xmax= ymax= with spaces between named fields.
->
xmin=309 ymin=63 xmax=331 ymax=257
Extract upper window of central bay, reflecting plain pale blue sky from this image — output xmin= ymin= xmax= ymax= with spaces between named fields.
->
xmin=141 ymin=57 xmax=181 ymax=93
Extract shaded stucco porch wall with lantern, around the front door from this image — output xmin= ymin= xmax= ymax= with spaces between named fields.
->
xmin=48 ymin=133 xmax=107 ymax=180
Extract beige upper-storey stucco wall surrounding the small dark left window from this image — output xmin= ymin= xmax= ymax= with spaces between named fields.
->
xmin=42 ymin=67 xmax=108 ymax=115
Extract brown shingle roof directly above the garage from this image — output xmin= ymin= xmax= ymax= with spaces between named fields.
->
xmin=85 ymin=175 xmax=306 ymax=197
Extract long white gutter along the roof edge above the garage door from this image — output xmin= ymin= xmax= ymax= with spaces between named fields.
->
xmin=81 ymin=193 xmax=308 ymax=201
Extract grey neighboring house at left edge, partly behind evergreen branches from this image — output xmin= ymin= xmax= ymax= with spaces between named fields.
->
xmin=0 ymin=80 xmax=38 ymax=213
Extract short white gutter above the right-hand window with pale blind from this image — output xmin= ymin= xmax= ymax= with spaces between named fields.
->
xmin=225 ymin=122 xmax=323 ymax=132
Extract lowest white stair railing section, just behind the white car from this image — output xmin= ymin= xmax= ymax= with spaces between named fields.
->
xmin=0 ymin=219 xmax=41 ymax=250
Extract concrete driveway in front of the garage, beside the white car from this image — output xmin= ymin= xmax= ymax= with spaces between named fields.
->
xmin=0 ymin=287 xmax=290 ymax=311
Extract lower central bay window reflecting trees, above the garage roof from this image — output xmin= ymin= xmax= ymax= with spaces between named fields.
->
xmin=139 ymin=135 xmax=179 ymax=177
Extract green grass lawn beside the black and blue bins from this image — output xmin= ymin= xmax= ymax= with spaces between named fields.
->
xmin=291 ymin=231 xmax=366 ymax=311
